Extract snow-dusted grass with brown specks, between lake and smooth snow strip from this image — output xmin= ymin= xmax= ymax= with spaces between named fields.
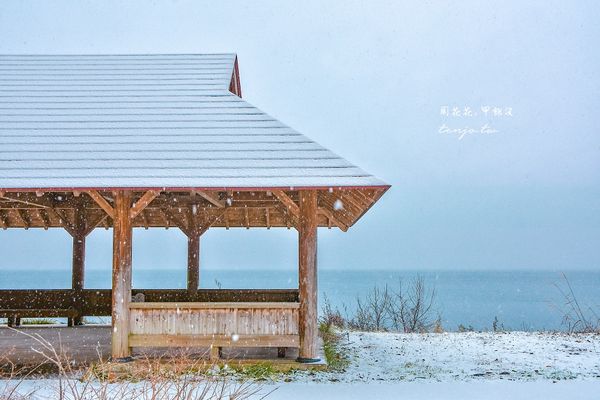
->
xmin=294 ymin=332 xmax=600 ymax=383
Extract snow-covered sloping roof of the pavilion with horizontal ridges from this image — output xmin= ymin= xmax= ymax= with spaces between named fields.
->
xmin=0 ymin=54 xmax=387 ymax=189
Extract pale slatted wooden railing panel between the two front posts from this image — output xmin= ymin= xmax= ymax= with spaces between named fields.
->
xmin=129 ymin=302 xmax=299 ymax=349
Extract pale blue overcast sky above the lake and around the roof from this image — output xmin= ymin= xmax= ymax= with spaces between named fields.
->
xmin=0 ymin=0 xmax=600 ymax=270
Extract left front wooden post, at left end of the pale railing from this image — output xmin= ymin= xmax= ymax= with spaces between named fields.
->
xmin=112 ymin=190 xmax=133 ymax=361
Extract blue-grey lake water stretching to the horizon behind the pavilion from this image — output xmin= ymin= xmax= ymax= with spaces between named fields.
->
xmin=0 ymin=268 xmax=600 ymax=330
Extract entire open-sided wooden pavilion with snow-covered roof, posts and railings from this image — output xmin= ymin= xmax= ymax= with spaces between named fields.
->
xmin=0 ymin=54 xmax=389 ymax=362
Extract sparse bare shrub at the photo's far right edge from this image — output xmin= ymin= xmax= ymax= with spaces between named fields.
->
xmin=555 ymin=273 xmax=600 ymax=333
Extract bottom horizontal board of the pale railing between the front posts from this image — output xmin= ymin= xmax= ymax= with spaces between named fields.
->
xmin=129 ymin=334 xmax=300 ymax=347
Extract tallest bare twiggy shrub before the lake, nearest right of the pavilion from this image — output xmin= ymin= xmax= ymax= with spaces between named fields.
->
xmin=387 ymin=276 xmax=436 ymax=333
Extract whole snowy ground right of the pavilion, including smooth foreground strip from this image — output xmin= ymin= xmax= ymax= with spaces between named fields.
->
xmin=0 ymin=332 xmax=600 ymax=400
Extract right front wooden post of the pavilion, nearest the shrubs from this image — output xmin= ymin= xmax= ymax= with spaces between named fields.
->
xmin=298 ymin=190 xmax=320 ymax=362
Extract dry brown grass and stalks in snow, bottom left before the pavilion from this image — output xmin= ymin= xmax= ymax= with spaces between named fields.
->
xmin=0 ymin=331 xmax=272 ymax=400
